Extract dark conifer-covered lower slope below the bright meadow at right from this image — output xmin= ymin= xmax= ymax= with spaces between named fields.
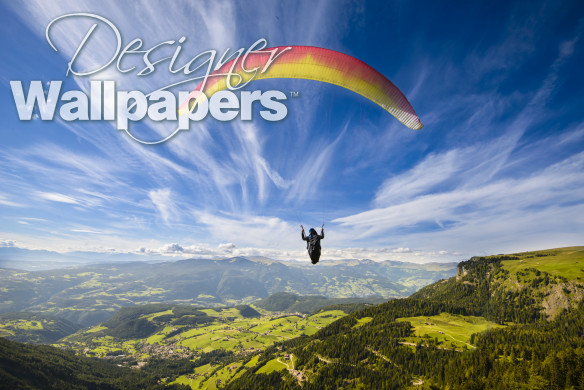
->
xmin=227 ymin=298 xmax=584 ymax=390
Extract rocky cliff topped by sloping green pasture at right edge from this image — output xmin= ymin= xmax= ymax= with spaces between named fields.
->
xmin=413 ymin=247 xmax=584 ymax=323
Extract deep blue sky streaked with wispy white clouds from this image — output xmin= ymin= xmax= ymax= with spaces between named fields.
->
xmin=0 ymin=0 xmax=584 ymax=262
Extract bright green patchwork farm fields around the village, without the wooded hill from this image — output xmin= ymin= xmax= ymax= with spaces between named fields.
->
xmin=57 ymin=308 xmax=346 ymax=359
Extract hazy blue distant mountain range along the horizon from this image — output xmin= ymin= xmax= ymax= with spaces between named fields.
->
xmin=0 ymin=257 xmax=456 ymax=326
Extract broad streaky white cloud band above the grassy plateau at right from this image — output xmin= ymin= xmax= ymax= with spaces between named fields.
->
xmin=335 ymin=143 xmax=584 ymax=250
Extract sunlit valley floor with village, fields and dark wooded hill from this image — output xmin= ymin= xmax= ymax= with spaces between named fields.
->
xmin=57 ymin=304 xmax=345 ymax=365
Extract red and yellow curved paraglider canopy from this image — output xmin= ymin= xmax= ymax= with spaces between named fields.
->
xmin=179 ymin=46 xmax=424 ymax=130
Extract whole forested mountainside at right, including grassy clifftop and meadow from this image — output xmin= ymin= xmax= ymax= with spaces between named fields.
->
xmin=221 ymin=247 xmax=584 ymax=389
